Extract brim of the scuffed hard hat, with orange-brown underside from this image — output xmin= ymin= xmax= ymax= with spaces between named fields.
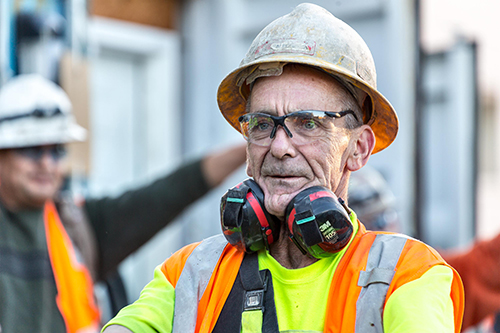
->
xmin=217 ymin=53 xmax=399 ymax=154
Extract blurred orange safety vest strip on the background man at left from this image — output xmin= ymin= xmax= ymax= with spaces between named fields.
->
xmin=44 ymin=202 xmax=100 ymax=333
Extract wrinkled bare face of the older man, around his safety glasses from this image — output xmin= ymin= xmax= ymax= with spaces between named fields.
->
xmin=247 ymin=66 xmax=356 ymax=218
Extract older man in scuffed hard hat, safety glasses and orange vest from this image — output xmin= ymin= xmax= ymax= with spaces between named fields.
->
xmin=104 ymin=4 xmax=464 ymax=333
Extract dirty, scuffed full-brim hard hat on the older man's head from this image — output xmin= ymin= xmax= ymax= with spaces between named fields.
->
xmin=217 ymin=3 xmax=399 ymax=153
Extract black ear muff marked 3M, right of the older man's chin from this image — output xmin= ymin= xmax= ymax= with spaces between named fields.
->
xmin=285 ymin=186 xmax=353 ymax=258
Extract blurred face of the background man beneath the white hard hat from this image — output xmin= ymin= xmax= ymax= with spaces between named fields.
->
xmin=0 ymin=145 xmax=63 ymax=211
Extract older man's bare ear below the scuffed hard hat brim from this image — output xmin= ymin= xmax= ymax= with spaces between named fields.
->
xmin=347 ymin=125 xmax=375 ymax=171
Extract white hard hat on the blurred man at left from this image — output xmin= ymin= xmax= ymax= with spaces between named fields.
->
xmin=0 ymin=74 xmax=87 ymax=149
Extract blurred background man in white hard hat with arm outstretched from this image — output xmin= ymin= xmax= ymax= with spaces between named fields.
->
xmin=0 ymin=75 xmax=246 ymax=333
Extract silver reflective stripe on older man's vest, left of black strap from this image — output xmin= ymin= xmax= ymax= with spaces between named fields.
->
xmin=172 ymin=234 xmax=227 ymax=333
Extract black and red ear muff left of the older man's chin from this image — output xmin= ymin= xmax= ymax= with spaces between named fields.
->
xmin=220 ymin=179 xmax=280 ymax=253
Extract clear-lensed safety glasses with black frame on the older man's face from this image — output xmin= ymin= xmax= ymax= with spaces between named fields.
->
xmin=240 ymin=111 xmax=340 ymax=146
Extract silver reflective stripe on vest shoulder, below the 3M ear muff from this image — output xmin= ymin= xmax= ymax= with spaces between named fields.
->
xmin=355 ymin=234 xmax=407 ymax=333
